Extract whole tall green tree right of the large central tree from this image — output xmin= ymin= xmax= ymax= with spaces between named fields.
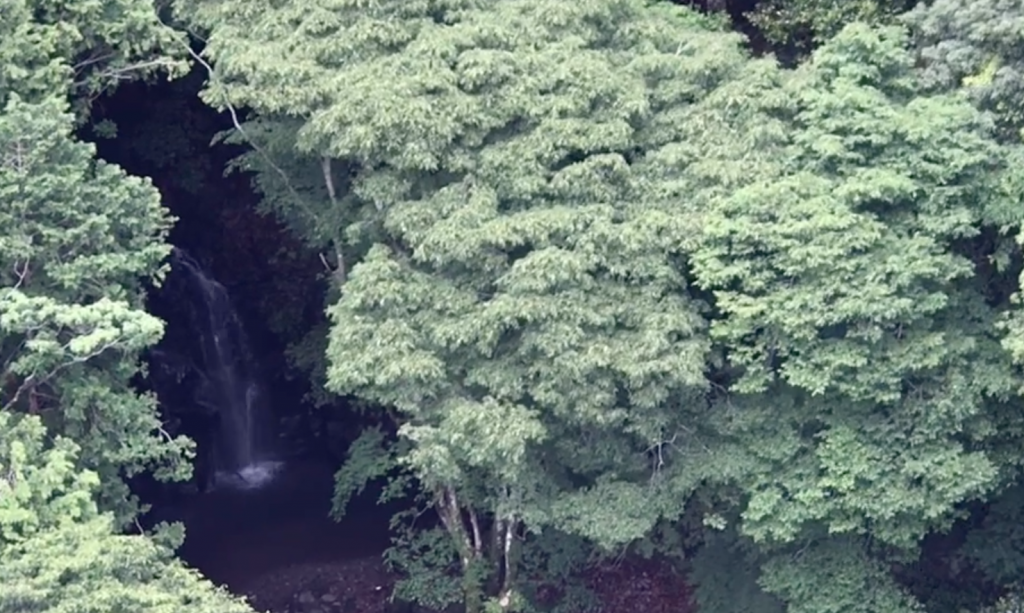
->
xmin=660 ymin=20 xmax=1021 ymax=613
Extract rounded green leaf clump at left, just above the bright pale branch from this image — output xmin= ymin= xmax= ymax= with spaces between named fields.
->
xmin=0 ymin=96 xmax=171 ymax=294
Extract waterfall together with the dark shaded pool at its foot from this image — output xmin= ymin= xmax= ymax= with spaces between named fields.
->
xmin=145 ymin=249 xmax=390 ymax=610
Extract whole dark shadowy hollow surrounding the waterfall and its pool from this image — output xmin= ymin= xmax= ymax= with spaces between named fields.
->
xmin=83 ymin=59 xmax=394 ymax=592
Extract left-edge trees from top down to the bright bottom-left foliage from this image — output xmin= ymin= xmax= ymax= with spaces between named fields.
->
xmin=0 ymin=0 xmax=189 ymax=522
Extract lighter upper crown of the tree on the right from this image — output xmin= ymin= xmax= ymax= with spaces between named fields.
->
xmin=694 ymin=27 xmax=999 ymax=401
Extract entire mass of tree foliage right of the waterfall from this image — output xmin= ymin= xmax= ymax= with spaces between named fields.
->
xmin=178 ymin=0 xmax=1024 ymax=613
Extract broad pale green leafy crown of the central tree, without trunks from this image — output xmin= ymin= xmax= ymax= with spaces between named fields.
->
xmin=307 ymin=1 xmax=724 ymax=564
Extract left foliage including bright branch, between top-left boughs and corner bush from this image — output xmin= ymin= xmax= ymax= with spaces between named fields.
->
xmin=0 ymin=95 xmax=190 ymax=519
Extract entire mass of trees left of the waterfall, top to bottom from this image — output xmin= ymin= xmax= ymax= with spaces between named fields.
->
xmin=0 ymin=0 xmax=256 ymax=613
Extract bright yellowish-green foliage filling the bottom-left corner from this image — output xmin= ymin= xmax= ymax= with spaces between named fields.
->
xmin=0 ymin=410 xmax=252 ymax=613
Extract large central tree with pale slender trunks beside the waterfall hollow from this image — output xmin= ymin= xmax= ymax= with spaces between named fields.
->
xmin=179 ymin=0 xmax=744 ymax=610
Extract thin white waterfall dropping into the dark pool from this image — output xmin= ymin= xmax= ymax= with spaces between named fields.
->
xmin=171 ymin=249 xmax=281 ymax=489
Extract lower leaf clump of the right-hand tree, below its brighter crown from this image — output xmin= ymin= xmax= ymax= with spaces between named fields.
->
xmin=743 ymin=425 xmax=997 ymax=550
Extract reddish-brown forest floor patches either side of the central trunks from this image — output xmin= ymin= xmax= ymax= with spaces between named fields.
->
xmin=236 ymin=556 xmax=695 ymax=613
